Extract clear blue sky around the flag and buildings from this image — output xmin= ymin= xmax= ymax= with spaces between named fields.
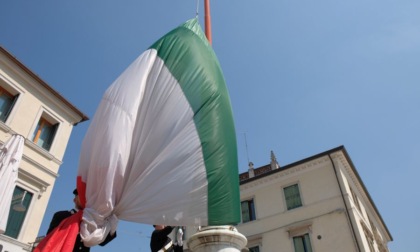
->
xmin=0 ymin=0 xmax=420 ymax=252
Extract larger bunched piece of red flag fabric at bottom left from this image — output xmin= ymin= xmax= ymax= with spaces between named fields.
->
xmin=34 ymin=211 xmax=83 ymax=252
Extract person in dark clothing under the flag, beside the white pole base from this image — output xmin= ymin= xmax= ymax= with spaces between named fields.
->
xmin=150 ymin=225 xmax=183 ymax=252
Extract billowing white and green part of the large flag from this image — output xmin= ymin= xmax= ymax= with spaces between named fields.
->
xmin=77 ymin=19 xmax=240 ymax=246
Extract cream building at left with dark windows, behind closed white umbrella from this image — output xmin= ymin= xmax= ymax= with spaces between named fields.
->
xmin=0 ymin=47 xmax=88 ymax=252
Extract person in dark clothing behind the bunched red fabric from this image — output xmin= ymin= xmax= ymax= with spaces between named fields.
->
xmin=47 ymin=189 xmax=117 ymax=252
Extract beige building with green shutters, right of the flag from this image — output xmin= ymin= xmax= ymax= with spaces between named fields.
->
xmin=237 ymin=146 xmax=392 ymax=252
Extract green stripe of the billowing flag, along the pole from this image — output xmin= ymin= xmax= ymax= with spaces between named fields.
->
xmin=151 ymin=19 xmax=240 ymax=225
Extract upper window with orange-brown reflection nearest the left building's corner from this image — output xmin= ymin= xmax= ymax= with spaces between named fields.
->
xmin=32 ymin=117 xmax=58 ymax=150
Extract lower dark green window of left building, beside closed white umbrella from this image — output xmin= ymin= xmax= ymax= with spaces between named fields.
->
xmin=4 ymin=186 xmax=32 ymax=239
